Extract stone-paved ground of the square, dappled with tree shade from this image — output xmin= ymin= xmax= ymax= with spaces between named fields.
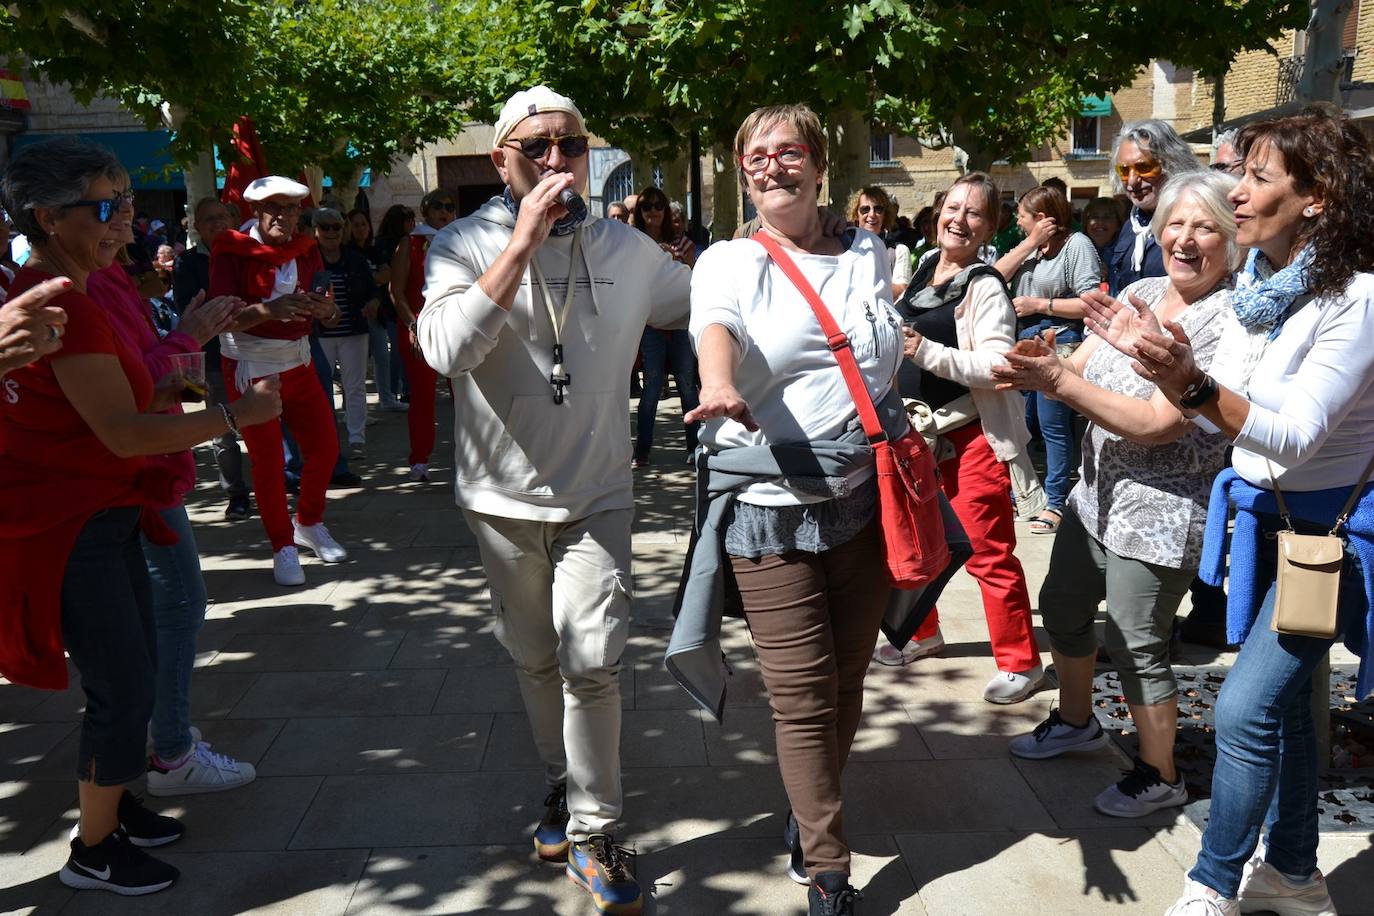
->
xmin=0 ymin=397 xmax=1374 ymax=916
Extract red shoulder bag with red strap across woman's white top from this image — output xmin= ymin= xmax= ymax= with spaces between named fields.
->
xmin=753 ymin=233 xmax=949 ymax=589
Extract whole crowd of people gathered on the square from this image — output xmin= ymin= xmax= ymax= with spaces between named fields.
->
xmin=0 ymin=87 xmax=1374 ymax=916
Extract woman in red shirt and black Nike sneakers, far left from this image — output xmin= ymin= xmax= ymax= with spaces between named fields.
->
xmin=0 ymin=140 xmax=280 ymax=895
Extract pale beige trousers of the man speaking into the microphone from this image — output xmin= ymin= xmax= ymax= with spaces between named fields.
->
xmin=463 ymin=509 xmax=633 ymax=842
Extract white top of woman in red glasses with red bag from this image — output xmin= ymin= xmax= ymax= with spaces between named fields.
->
xmin=691 ymin=229 xmax=901 ymax=505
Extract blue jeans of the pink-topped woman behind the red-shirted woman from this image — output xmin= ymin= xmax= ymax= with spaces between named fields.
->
xmin=143 ymin=505 xmax=207 ymax=759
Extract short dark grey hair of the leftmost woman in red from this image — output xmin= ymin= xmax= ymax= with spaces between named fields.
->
xmin=0 ymin=137 xmax=129 ymax=243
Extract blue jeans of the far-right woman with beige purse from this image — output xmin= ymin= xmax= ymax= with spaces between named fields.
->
xmin=1189 ymin=516 xmax=1364 ymax=898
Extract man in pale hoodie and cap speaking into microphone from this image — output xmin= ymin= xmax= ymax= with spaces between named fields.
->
xmin=418 ymin=87 xmax=690 ymax=913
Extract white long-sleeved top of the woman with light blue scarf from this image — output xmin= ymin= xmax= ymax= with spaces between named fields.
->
xmin=1231 ymin=273 xmax=1374 ymax=492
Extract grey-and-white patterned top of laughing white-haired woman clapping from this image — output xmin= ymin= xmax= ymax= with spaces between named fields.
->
xmin=1069 ymin=277 xmax=1231 ymax=569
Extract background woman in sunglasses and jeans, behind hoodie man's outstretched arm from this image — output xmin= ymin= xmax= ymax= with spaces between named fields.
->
xmin=629 ymin=185 xmax=701 ymax=467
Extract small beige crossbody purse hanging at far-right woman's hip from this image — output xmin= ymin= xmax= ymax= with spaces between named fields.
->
xmin=1265 ymin=459 xmax=1374 ymax=639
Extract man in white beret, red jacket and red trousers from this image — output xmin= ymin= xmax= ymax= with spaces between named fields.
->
xmin=207 ymin=174 xmax=348 ymax=585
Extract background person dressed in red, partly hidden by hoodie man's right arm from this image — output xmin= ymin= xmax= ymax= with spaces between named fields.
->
xmin=392 ymin=190 xmax=458 ymax=481
